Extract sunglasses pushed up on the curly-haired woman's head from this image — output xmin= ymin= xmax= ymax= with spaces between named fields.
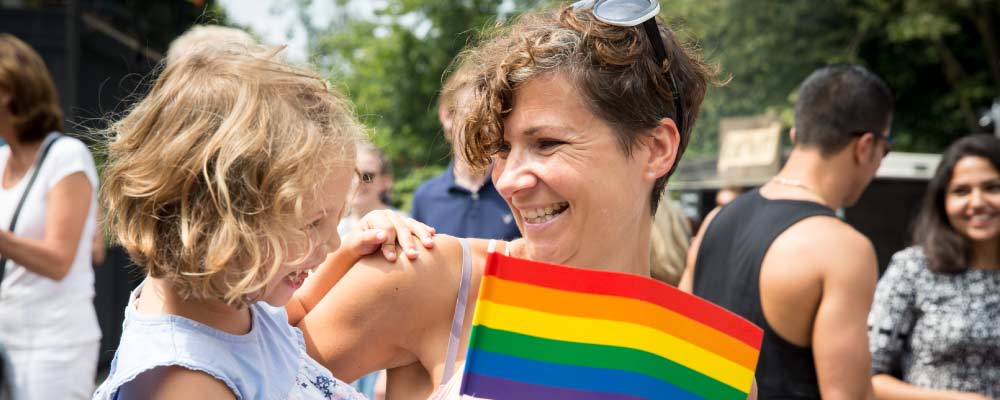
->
xmin=571 ymin=0 xmax=684 ymax=132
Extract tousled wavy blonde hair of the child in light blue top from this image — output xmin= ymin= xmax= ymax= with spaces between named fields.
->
xmin=101 ymin=45 xmax=364 ymax=306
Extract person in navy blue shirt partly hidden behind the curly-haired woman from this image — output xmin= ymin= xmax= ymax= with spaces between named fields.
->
xmin=411 ymin=69 xmax=521 ymax=240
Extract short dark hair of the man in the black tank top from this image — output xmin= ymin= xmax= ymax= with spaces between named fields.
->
xmin=795 ymin=65 xmax=895 ymax=156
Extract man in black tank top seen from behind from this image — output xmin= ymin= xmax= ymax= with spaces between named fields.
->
xmin=680 ymin=65 xmax=893 ymax=400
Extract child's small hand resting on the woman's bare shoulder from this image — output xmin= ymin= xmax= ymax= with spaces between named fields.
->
xmin=345 ymin=210 xmax=435 ymax=261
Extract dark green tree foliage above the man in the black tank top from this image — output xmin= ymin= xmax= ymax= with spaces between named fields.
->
xmin=676 ymin=0 xmax=1000 ymax=153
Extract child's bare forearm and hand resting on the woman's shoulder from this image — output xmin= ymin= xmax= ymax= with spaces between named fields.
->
xmin=285 ymin=210 xmax=434 ymax=325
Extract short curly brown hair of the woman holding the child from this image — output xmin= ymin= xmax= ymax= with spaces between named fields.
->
xmin=457 ymin=5 xmax=717 ymax=212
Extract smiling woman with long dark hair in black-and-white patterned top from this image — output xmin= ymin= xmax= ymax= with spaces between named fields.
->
xmin=868 ymin=135 xmax=1000 ymax=399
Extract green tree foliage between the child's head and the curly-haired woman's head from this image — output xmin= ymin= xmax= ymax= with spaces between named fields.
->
xmin=298 ymin=0 xmax=538 ymax=207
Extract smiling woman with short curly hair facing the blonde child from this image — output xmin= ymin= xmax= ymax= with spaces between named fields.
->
xmin=298 ymin=1 xmax=732 ymax=399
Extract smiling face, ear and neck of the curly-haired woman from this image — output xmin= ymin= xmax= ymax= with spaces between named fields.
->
xmin=493 ymin=73 xmax=664 ymax=275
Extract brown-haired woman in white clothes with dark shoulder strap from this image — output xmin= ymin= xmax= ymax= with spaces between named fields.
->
xmin=0 ymin=34 xmax=101 ymax=399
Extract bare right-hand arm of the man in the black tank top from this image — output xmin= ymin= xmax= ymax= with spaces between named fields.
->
xmin=808 ymin=225 xmax=878 ymax=400
